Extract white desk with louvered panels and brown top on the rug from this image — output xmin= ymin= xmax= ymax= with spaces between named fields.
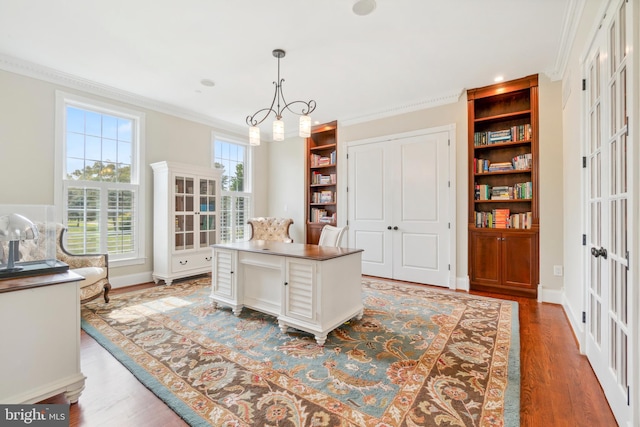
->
xmin=210 ymin=240 xmax=363 ymax=345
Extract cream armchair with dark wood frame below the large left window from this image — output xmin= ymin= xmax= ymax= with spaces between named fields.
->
xmin=4 ymin=223 xmax=111 ymax=303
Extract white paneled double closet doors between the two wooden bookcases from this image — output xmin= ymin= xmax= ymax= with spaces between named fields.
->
xmin=347 ymin=128 xmax=454 ymax=287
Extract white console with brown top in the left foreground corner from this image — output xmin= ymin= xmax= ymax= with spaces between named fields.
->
xmin=0 ymin=271 xmax=85 ymax=404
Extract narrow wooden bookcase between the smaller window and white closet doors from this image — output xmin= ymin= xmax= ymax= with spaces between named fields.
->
xmin=305 ymin=121 xmax=338 ymax=245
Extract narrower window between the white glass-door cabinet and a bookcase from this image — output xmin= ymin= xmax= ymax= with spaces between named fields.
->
xmin=213 ymin=137 xmax=251 ymax=243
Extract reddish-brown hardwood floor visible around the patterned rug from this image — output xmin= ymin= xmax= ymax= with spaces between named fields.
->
xmin=42 ymin=283 xmax=617 ymax=427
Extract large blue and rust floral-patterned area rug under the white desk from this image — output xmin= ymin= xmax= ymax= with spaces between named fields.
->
xmin=82 ymin=277 xmax=520 ymax=427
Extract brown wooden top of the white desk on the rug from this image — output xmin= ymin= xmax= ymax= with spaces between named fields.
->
xmin=211 ymin=240 xmax=363 ymax=261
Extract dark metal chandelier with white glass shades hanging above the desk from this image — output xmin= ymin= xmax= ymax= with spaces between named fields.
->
xmin=247 ymin=49 xmax=316 ymax=145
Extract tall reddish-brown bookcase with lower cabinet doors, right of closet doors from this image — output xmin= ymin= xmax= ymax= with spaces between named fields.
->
xmin=467 ymin=75 xmax=540 ymax=298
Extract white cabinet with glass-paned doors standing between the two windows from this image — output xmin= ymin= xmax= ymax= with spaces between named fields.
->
xmin=151 ymin=162 xmax=221 ymax=285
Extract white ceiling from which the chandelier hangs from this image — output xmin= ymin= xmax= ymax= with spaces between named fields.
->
xmin=0 ymin=0 xmax=579 ymax=137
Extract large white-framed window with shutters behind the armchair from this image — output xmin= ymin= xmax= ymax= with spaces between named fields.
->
xmin=56 ymin=92 xmax=144 ymax=265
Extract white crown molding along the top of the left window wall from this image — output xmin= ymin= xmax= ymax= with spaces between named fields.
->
xmin=0 ymin=53 xmax=246 ymax=135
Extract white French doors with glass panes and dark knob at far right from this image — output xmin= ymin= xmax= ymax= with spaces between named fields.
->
xmin=584 ymin=0 xmax=638 ymax=425
